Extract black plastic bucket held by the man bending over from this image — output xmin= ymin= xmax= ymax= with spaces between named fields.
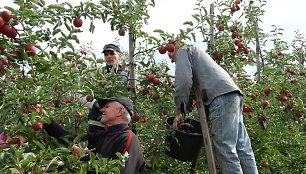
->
xmin=165 ymin=117 xmax=203 ymax=161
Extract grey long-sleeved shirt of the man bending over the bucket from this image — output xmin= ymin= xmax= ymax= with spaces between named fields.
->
xmin=175 ymin=47 xmax=240 ymax=105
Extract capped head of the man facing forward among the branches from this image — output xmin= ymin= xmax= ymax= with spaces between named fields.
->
xmin=102 ymin=44 xmax=122 ymax=67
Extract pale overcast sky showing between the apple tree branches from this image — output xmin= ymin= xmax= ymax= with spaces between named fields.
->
xmin=0 ymin=0 xmax=306 ymax=72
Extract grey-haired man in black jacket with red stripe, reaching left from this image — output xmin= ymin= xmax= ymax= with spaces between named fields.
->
xmin=44 ymin=96 xmax=145 ymax=174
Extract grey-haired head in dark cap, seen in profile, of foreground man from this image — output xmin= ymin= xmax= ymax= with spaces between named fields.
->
xmin=98 ymin=96 xmax=133 ymax=126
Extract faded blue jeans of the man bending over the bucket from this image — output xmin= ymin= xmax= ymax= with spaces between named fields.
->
xmin=209 ymin=92 xmax=258 ymax=174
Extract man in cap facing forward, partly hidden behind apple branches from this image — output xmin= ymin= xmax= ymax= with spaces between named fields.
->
xmin=81 ymin=44 xmax=128 ymax=136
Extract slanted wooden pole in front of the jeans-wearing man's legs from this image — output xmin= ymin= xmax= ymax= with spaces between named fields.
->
xmin=195 ymin=88 xmax=217 ymax=174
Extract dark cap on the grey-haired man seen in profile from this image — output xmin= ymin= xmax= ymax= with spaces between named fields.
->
xmin=98 ymin=96 xmax=133 ymax=116
